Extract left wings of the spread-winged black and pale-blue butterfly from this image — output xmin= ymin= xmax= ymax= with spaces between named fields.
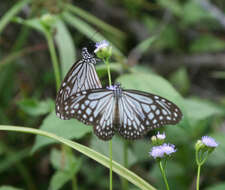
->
xmin=64 ymin=89 xmax=115 ymax=140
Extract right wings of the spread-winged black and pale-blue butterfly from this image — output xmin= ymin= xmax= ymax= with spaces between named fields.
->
xmin=118 ymin=90 xmax=182 ymax=139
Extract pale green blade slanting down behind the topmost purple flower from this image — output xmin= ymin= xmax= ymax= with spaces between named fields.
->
xmin=63 ymin=12 xmax=123 ymax=56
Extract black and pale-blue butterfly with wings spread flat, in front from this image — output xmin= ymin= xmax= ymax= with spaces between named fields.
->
xmin=55 ymin=83 xmax=182 ymax=140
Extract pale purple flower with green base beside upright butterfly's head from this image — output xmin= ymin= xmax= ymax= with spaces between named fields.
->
xmin=94 ymin=40 xmax=112 ymax=59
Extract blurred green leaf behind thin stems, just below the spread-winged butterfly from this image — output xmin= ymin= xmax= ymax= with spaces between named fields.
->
xmin=91 ymin=136 xmax=137 ymax=166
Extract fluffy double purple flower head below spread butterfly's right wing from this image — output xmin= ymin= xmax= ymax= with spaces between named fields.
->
xmin=149 ymin=143 xmax=177 ymax=159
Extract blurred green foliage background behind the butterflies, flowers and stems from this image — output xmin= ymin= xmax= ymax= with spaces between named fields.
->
xmin=0 ymin=0 xmax=225 ymax=190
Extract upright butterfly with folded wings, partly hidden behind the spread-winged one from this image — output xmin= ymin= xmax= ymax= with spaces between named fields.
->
xmin=55 ymin=43 xmax=102 ymax=119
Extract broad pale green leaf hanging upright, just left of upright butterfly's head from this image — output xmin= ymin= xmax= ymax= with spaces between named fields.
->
xmin=55 ymin=20 xmax=76 ymax=76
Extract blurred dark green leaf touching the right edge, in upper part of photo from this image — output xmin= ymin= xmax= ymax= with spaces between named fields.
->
xmin=190 ymin=34 xmax=225 ymax=53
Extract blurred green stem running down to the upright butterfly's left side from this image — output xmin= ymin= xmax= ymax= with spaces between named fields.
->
xmin=45 ymin=31 xmax=60 ymax=90
